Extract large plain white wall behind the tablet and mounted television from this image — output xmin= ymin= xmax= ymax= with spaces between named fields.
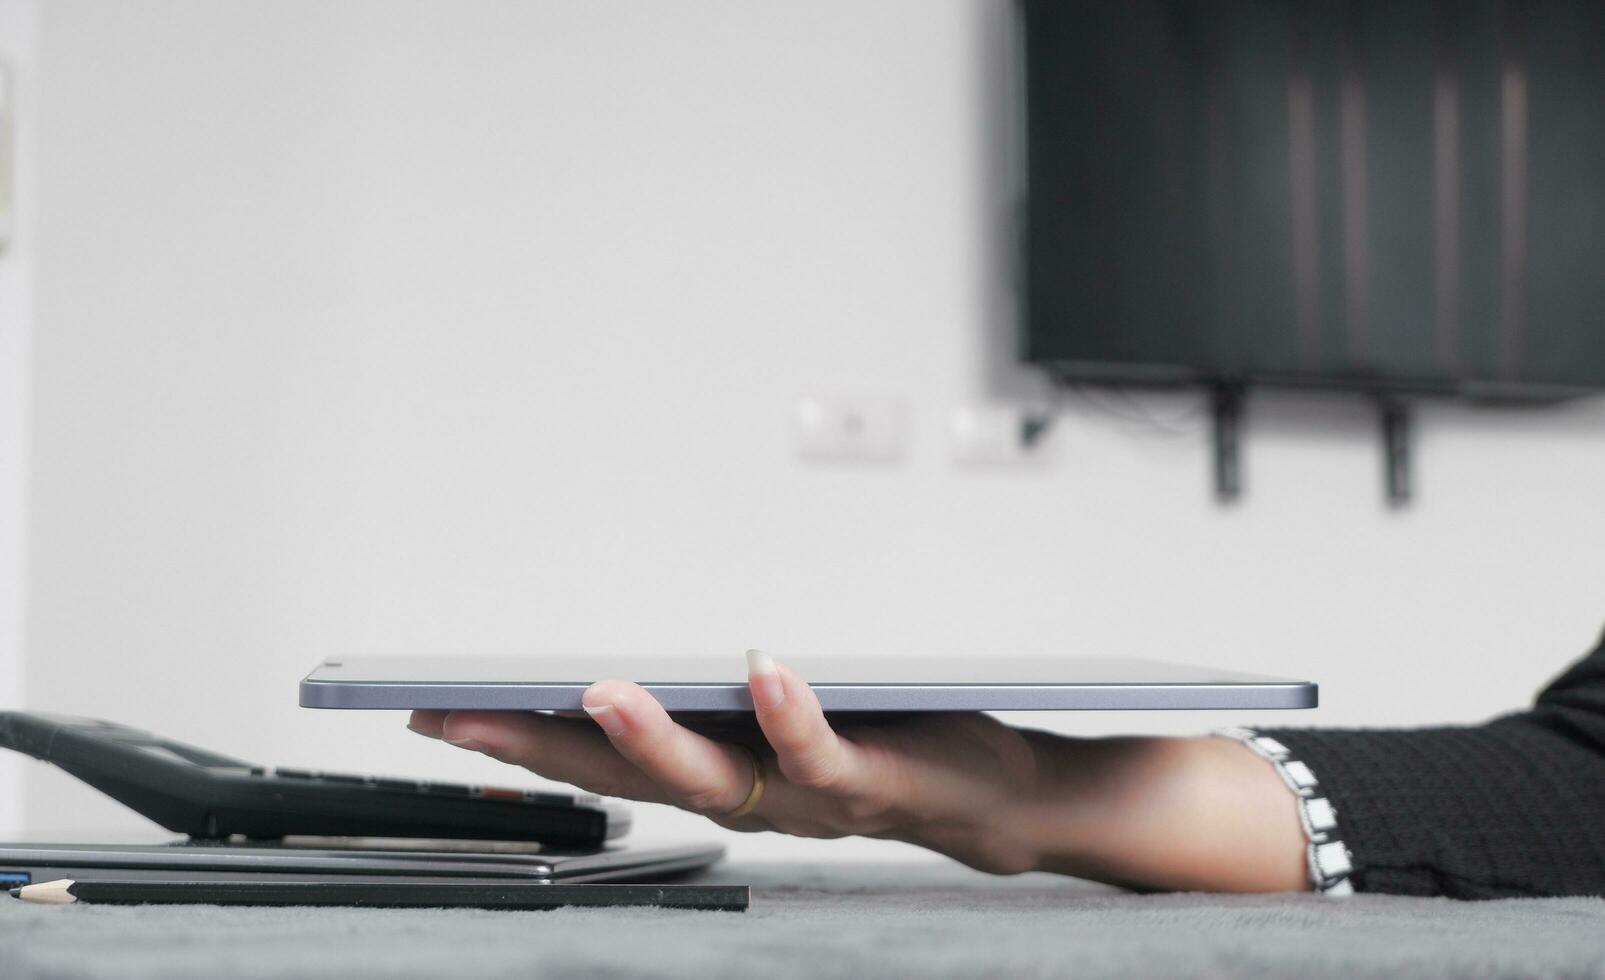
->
xmin=26 ymin=0 xmax=1605 ymax=853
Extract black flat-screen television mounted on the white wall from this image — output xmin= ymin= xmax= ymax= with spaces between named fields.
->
xmin=1018 ymin=0 xmax=1605 ymax=398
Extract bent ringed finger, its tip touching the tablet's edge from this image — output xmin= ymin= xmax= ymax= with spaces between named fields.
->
xmin=581 ymin=680 xmax=753 ymax=816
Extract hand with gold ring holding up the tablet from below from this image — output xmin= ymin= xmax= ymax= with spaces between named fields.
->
xmin=408 ymin=650 xmax=1040 ymax=873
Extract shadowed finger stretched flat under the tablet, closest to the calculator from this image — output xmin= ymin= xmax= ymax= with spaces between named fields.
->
xmin=414 ymin=711 xmax=669 ymax=804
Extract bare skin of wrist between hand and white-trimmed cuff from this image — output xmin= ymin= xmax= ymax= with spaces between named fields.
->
xmin=1024 ymin=731 xmax=1310 ymax=892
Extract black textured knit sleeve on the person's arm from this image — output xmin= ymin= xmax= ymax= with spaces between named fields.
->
xmin=1265 ymin=628 xmax=1605 ymax=898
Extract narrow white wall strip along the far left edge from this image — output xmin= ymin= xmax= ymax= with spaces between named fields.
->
xmin=0 ymin=0 xmax=39 ymax=839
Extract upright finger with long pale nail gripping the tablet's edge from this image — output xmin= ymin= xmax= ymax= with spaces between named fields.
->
xmin=746 ymin=650 xmax=867 ymax=796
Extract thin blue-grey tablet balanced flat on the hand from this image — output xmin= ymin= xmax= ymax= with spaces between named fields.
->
xmin=300 ymin=656 xmax=1318 ymax=712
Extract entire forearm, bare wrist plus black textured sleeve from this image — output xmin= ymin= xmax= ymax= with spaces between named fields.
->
xmin=1001 ymin=628 xmax=1605 ymax=898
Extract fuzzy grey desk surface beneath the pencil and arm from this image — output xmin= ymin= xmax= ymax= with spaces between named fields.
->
xmin=0 ymin=863 xmax=1605 ymax=980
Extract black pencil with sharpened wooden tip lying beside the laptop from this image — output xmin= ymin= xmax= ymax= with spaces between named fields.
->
xmin=11 ymin=877 xmax=751 ymax=913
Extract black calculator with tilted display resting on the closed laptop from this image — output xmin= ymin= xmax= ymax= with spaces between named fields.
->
xmin=0 ymin=712 xmax=629 ymax=848
